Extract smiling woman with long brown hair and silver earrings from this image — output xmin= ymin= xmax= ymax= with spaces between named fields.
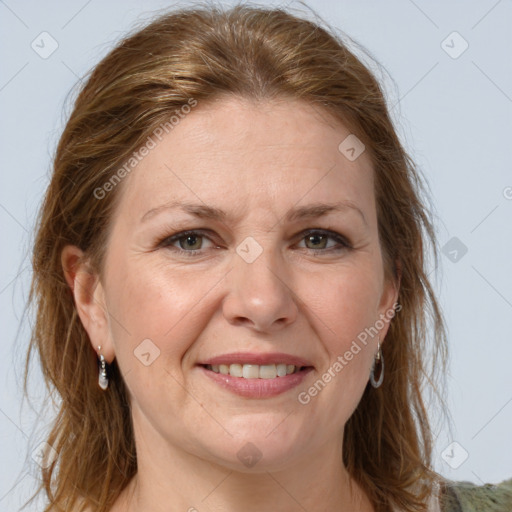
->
xmin=26 ymin=7 xmax=512 ymax=512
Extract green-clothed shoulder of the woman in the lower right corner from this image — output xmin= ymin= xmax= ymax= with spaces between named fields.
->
xmin=439 ymin=479 xmax=512 ymax=512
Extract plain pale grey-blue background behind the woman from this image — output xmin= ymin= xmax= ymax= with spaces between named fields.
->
xmin=0 ymin=0 xmax=512 ymax=511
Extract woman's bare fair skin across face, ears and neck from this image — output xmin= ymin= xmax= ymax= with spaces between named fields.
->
xmin=62 ymin=97 xmax=398 ymax=512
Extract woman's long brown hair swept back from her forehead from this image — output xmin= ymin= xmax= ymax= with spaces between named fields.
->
xmin=25 ymin=6 xmax=446 ymax=512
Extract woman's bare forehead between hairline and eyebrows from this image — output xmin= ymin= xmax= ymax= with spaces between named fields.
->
xmin=115 ymin=97 xmax=374 ymax=224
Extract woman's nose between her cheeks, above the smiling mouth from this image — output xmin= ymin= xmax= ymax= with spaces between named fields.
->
xmin=222 ymin=242 xmax=298 ymax=333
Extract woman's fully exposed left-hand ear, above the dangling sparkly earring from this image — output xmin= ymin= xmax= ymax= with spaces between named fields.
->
xmin=61 ymin=245 xmax=115 ymax=363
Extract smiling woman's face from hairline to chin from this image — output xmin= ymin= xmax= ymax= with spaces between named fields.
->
xmin=74 ymin=98 xmax=397 ymax=471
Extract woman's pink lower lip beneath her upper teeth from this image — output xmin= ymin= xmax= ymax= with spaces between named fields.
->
xmin=199 ymin=366 xmax=313 ymax=398
